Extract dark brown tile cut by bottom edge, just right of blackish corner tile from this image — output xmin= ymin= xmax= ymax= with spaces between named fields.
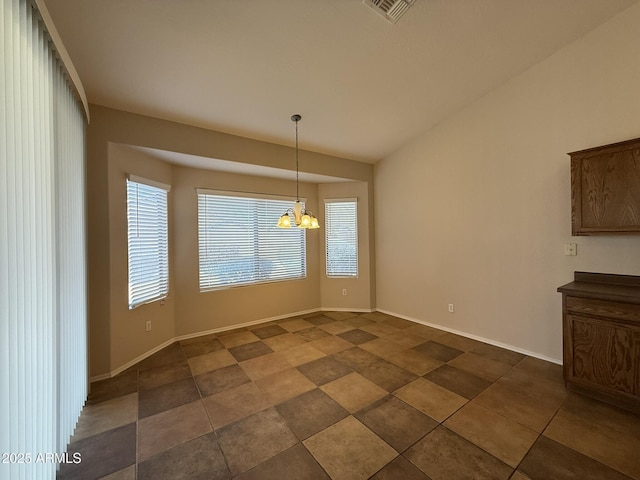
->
xmin=137 ymin=432 xmax=231 ymax=480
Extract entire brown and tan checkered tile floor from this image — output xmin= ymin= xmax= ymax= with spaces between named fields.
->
xmin=58 ymin=312 xmax=640 ymax=480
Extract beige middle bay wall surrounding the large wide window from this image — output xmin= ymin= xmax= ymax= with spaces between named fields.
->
xmin=172 ymin=166 xmax=321 ymax=335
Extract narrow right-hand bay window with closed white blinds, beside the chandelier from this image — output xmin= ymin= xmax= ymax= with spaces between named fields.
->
xmin=325 ymin=198 xmax=358 ymax=277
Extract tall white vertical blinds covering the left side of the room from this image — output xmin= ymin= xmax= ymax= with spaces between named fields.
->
xmin=0 ymin=0 xmax=87 ymax=479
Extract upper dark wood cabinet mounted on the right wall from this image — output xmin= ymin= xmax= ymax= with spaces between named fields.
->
xmin=569 ymin=138 xmax=640 ymax=235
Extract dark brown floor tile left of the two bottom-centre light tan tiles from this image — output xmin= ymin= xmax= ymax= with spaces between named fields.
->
xmin=276 ymin=388 xmax=349 ymax=440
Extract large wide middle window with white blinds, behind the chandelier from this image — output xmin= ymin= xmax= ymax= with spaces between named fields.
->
xmin=198 ymin=190 xmax=307 ymax=291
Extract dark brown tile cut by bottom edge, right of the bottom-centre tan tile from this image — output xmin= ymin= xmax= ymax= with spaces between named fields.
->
xmin=404 ymin=427 xmax=510 ymax=480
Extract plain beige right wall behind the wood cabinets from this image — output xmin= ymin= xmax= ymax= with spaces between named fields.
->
xmin=375 ymin=5 xmax=640 ymax=360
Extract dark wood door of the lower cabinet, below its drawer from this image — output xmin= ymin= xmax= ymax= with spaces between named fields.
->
xmin=568 ymin=315 xmax=639 ymax=395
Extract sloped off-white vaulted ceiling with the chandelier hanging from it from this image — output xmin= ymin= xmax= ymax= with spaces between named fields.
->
xmin=46 ymin=0 xmax=638 ymax=162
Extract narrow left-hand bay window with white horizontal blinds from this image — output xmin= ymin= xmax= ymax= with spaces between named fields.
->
xmin=127 ymin=175 xmax=170 ymax=309
